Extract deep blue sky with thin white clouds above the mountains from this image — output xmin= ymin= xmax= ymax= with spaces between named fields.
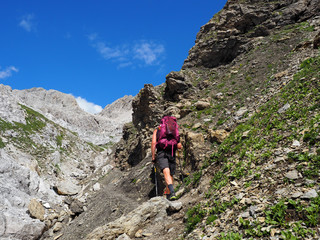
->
xmin=0 ymin=0 xmax=226 ymax=112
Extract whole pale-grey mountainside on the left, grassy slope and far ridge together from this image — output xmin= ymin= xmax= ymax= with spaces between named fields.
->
xmin=0 ymin=84 xmax=132 ymax=239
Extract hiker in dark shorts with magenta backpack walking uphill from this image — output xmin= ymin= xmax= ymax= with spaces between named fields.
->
xmin=151 ymin=116 xmax=182 ymax=201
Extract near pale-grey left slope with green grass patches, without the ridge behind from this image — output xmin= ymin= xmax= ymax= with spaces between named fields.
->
xmin=0 ymin=85 xmax=120 ymax=239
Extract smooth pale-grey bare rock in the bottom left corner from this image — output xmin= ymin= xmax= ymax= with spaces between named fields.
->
xmin=0 ymin=149 xmax=61 ymax=239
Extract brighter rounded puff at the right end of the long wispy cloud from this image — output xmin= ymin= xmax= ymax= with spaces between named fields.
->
xmin=134 ymin=42 xmax=164 ymax=65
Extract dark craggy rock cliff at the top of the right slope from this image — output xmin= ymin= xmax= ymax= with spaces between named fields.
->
xmin=182 ymin=0 xmax=320 ymax=69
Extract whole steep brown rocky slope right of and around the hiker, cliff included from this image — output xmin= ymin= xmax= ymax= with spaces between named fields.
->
xmin=75 ymin=0 xmax=320 ymax=239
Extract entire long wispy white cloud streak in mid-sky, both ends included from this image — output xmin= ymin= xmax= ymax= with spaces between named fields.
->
xmin=88 ymin=33 xmax=165 ymax=69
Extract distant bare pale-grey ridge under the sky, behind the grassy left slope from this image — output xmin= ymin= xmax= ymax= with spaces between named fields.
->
xmin=13 ymin=88 xmax=133 ymax=144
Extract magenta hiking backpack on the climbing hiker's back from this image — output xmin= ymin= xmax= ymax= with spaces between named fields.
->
xmin=157 ymin=116 xmax=180 ymax=156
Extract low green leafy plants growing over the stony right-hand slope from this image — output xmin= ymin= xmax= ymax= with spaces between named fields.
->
xmin=185 ymin=51 xmax=320 ymax=236
